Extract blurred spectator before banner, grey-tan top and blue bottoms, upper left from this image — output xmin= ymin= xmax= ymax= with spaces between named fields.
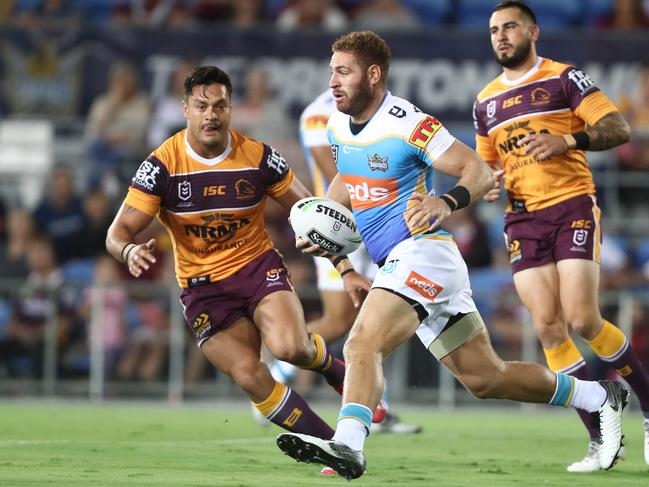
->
xmin=86 ymin=61 xmax=151 ymax=187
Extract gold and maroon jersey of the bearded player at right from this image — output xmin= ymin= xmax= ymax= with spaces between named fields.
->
xmin=473 ymin=57 xmax=617 ymax=211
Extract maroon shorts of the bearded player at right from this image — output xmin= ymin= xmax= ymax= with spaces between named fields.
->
xmin=505 ymin=195 xmax=602 ymax=273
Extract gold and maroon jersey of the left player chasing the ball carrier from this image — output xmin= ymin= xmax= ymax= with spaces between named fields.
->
xmin=124 ymin=130 xmax=294 ymax=287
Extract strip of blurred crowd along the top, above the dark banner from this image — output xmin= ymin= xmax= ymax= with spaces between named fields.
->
xmin=0 ymin=0 xmax=649 ymax=31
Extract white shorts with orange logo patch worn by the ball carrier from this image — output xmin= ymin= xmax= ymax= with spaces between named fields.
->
xmin=372 ymin=236 xmax=477 ymax=348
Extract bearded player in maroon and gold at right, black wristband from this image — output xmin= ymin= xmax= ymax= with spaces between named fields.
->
xmin=474 ymin=1 xmax=649 ymax=472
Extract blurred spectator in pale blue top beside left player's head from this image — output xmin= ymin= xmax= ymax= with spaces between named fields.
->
xmin=147 ymin=61 xmax=193 ymax=150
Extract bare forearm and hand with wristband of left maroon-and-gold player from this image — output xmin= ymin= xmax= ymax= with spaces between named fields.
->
xmin=106 ymin=204 xmax=156 ymax=277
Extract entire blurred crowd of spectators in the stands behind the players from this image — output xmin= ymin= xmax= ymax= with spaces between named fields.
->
xmin=0 ymin=0 xmax=649 ymax=383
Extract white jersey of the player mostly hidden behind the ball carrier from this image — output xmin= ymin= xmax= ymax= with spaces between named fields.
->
xmin=300 ymin=90 xmax=336 ymax=196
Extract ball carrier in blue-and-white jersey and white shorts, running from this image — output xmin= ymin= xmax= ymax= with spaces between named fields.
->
xmin=277 ymin=31 xmax=628 ymax=479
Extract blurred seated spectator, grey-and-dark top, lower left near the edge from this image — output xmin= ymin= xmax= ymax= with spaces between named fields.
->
xmin=0 ymin=236 xmax=75 ymax=378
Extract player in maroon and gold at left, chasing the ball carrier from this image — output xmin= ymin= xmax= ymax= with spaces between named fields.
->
xmin=106 ymin=66 xmax=365 ymax=438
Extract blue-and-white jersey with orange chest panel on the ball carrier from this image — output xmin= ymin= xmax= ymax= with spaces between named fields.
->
xmin=327 ymin=92 xmax=455 ymax=263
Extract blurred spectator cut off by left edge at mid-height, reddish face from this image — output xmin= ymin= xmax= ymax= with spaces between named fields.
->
xmin=0 ymin=208 xmax=34 ymax=279
